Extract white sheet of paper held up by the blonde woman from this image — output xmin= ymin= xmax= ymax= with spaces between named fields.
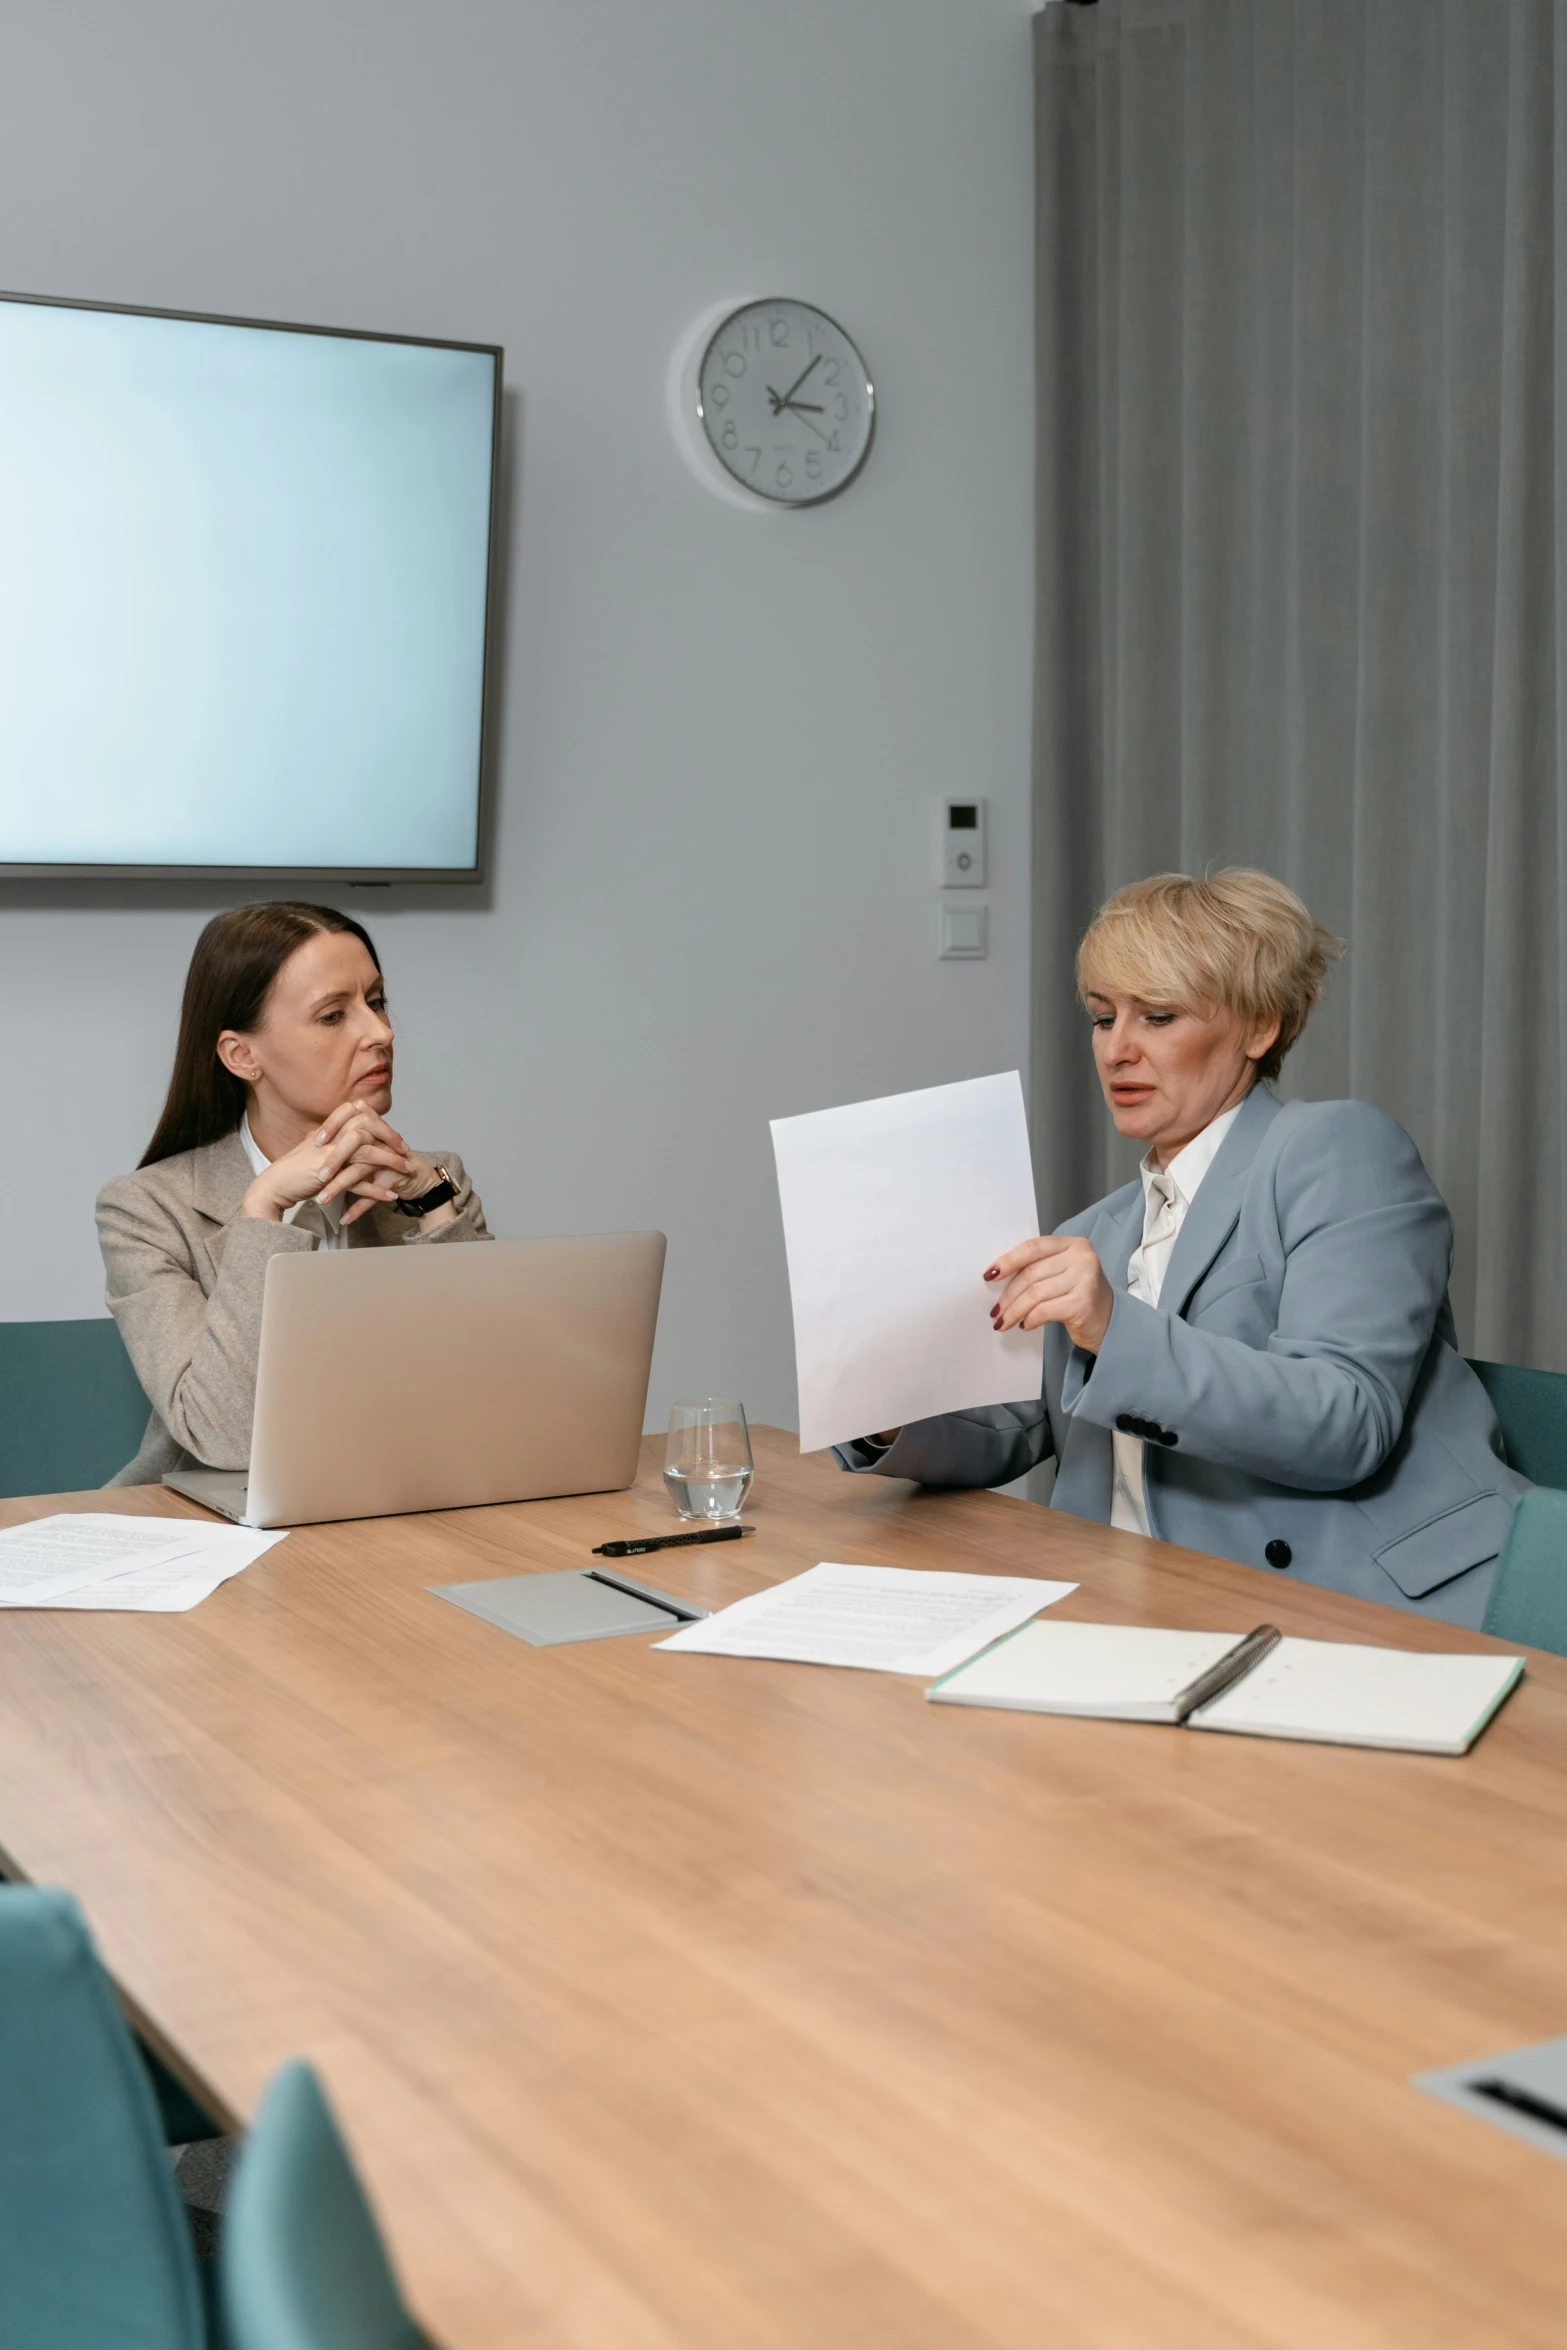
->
xmin=773 ymin=1069 xmax=1043 ymax=1452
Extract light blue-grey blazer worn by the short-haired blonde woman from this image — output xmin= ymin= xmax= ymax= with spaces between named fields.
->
xmin=836 ymin=1086 xmax=1529 ymax=1629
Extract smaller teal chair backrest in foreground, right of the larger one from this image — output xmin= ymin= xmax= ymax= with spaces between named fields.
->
xmin=218 ymin=2063 xmax=421 ymax=2350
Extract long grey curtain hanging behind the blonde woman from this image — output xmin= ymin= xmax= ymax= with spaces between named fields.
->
xmin=1034 ymin=0 xmax=1567 ymax=1370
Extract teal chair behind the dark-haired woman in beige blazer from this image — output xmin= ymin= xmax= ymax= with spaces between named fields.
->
xmin=0 ymin=1321 xmax=148 ymax=1499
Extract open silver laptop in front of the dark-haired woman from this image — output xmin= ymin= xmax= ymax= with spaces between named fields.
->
xmin=164 ymin=1231 xmax=665 ymax=1525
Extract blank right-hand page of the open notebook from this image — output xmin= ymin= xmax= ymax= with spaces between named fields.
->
xmin=1191 ymin=1640 xmax=1522 ymax=1753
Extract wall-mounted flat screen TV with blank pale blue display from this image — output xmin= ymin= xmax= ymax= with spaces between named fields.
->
xmin=0 ymin=296 xmax=500 ymax=881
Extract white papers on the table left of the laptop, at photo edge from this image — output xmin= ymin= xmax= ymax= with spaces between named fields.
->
xmin=0 ymin=1511 xmax=282 ymax=1614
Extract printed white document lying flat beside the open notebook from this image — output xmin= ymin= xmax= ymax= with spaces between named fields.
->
xmin=653 ymin=1560 xmax=1078 ymax=1676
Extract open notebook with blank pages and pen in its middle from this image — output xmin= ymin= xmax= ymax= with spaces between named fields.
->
xmin=926 ymin=1622 xmax=1522 ymax=1755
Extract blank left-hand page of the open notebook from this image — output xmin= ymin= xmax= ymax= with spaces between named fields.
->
xmin=926 ymin=1624 xmax=1240 ymax=1716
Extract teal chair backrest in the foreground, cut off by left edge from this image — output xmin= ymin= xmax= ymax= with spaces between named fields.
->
xmin=0 ymin=1885 xmax=204 ymax=2350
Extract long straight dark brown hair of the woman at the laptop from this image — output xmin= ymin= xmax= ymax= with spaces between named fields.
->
xmin=141 ymin=905 xmax=381 ymax=1168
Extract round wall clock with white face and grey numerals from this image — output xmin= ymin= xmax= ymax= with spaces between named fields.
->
xmin=695 ymin=301 xmax=876 ymax=505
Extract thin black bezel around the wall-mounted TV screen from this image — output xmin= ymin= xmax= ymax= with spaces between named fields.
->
xmin=0 ymin=291 xmax=505 ymax=884
